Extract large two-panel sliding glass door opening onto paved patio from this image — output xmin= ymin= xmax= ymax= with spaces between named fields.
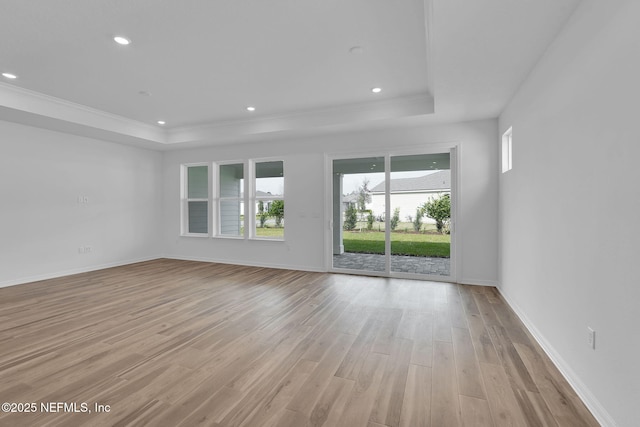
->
xmin=331 ymin=150 xmax=455 ymax=280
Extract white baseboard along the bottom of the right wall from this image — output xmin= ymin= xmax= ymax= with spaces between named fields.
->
xmin=498 ymin=288 xmax=618 ymax=427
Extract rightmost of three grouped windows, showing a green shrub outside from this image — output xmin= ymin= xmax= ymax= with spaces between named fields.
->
xmin=249 ymin=160 xmax=285 ymax=239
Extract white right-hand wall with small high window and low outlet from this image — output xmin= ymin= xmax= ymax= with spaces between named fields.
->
xmin=496 ymin=0 xmax=640 ymax=427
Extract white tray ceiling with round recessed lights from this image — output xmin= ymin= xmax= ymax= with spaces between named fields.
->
xmin=0 ymin=0 xmax=579 ymax=148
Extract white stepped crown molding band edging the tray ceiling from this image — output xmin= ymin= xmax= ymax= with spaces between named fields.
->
xmin=0 ymin=82 xmax=434 ymax=150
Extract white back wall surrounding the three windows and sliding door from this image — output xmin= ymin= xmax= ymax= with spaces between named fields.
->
xmin=163 ymin=120 xmax=498 ymax=284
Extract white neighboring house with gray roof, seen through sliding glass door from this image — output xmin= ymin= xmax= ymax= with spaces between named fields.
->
xmin=368 ymin=170 xmax=451 ymax=224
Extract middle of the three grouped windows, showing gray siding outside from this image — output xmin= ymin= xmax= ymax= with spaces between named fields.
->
xmin=218 ymin=163 xmax=244 ymax=237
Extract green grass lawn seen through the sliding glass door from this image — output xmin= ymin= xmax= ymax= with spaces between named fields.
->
xmin=342 ymin=231 xmax=451 ymax=257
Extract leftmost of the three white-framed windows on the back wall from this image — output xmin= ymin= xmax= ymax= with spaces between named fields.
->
xmin=182 ymin=165 xmax=209 ymax=235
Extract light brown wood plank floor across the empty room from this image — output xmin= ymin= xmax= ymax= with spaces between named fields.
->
xmin=0 ymin=260 xmax=598 ymax=427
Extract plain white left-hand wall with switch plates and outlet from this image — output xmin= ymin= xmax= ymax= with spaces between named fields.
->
xmin=0 ymin=121 xmax=162 ymax=286
